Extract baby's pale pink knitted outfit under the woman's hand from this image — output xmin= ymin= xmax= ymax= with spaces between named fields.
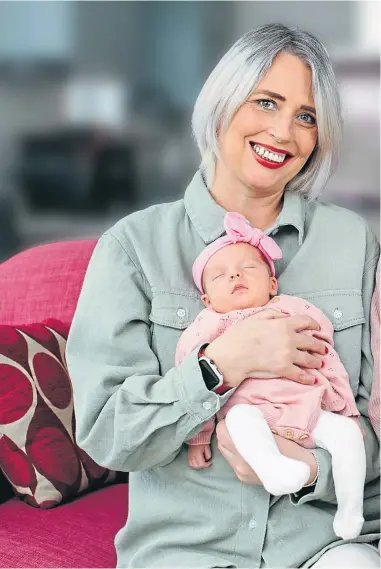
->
xmin=175 ymin=294 xmax=359 ymax=448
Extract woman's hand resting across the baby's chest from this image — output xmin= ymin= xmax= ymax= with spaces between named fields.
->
xmin=205 ymin=309 xmax=326 ymax=387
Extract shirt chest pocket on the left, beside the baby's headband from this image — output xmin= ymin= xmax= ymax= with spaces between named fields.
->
xmin=149 ymin=288 xmax=204 ymax=375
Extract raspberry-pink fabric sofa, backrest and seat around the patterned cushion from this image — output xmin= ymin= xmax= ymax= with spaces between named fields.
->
xmin=0 ymin=240 xmax=128 ymax=568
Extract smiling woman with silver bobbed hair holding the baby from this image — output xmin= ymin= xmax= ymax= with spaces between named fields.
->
xmin=67 ymin=25 xmax=379 ymax=567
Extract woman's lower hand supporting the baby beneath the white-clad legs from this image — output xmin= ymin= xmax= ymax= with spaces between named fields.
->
xmin=216 ymin=420 xmax=317 ymax=485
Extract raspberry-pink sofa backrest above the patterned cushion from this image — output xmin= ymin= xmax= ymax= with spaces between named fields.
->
xmin=0 ymin=239 xmax=96 ymax=324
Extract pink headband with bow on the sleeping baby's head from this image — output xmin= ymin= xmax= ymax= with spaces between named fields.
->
xmin=192 ymin=212 xmax=282 ymax=294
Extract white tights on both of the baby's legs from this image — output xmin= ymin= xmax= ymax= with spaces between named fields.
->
xmin=225 ymin=404 xmax=366 ymax=539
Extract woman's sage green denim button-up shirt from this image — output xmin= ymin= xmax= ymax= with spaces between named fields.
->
xmin=67 ymin=172 xmax=379 ymax=567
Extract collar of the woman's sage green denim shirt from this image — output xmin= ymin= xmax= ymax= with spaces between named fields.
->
xmin=184 ymin=170 xmax=306 ymax=246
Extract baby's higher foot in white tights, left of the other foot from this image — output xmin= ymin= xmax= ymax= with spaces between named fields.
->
xmin=259 ymin=455 xmax=310 ymax=496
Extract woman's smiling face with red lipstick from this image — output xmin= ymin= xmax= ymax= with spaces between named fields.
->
xmin=217 ymin=52 xmax=318 ymax=195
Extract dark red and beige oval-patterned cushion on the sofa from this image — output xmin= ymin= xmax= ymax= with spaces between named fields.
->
xmin=0 ymin=319 xmax=116 ymax=509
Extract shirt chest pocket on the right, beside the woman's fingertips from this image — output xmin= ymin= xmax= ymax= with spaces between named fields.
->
xmin=304 ymin=290 xmax=365 ymax=395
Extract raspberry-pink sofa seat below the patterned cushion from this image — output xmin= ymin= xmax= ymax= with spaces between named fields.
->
xmin=0 ymin=484 xmax=128 ymax=568
